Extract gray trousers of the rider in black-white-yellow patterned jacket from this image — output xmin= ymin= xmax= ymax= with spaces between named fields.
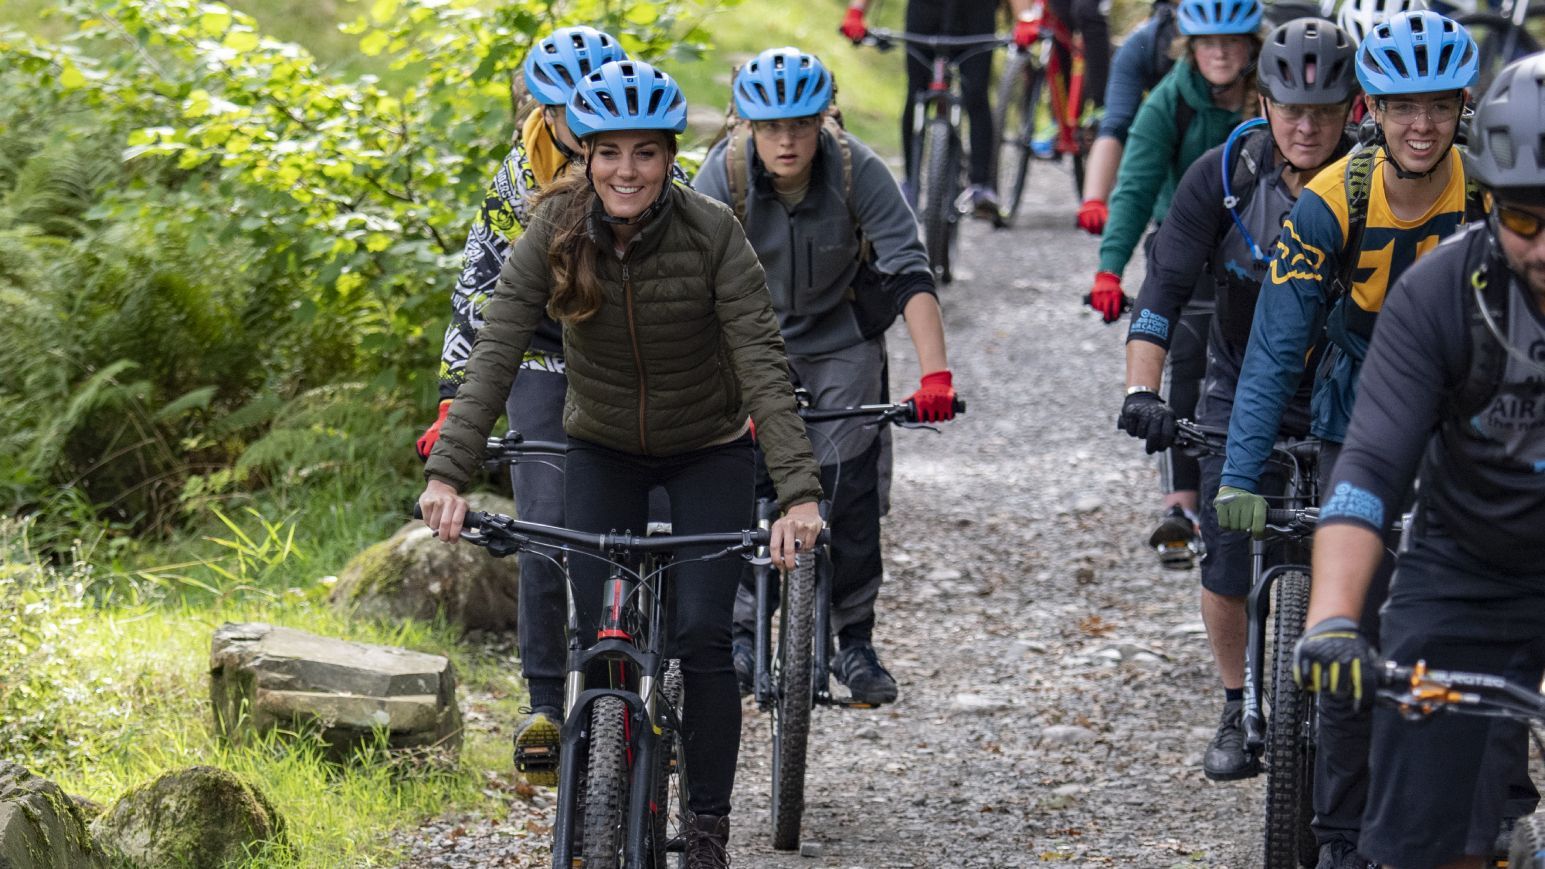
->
xmin=505 ymin=368 xmax=569 ymax=680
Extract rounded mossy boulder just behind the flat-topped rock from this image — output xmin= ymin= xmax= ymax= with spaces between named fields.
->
xmin=331 ymin=493 xmax=521 ymax=634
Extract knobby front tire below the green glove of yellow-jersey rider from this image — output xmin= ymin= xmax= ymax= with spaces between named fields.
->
xmin=1265 ymin=571 xmax=1318 ymax=869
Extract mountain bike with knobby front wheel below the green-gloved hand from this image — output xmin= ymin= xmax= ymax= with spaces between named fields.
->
xmin=1176 ymin=419 xmax=1319 ymax=869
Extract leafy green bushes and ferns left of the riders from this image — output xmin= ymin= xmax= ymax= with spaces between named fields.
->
xmin=0 ymin=0 xmax=723 ymax=538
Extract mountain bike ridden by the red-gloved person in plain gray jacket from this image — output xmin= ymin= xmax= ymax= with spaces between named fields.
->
xmin=751 ymin=390 xmax=966 ymax=850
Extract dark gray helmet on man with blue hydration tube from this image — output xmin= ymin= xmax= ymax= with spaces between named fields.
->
xmin=1256 ymin=19 xmax=1357 ymax=105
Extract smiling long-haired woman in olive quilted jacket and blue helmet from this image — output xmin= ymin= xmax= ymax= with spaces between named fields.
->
xmin=419 ymin=60 xmax=822 ymax=869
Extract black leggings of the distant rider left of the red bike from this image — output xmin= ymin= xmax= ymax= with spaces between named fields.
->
xmin=901 ymin=0 xmax=998 ymax=187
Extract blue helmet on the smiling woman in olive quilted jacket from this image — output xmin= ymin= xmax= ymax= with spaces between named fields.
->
xmin=567 ymin=60 xmax=686 ymax=139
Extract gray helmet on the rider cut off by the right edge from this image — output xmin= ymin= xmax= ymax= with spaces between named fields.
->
xmin=1465 ymin=54 xmax=1545 ymax=196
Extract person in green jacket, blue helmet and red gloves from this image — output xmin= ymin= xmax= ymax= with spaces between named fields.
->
xmin=1086 ymin=0 xmax=1261 ymax=569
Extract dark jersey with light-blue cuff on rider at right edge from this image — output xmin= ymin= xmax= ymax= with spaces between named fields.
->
xmin=1321 ymin=224 xmax=1545 ymax=574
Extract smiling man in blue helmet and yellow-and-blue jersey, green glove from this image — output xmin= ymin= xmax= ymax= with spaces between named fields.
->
xmin=1214 ymin=11 xmax=1479 ymax=867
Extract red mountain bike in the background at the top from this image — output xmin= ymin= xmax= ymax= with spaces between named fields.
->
xmin=993 ymin=0 xmax=1092 ymax=224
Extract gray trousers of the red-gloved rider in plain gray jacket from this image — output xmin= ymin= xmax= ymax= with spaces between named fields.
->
xmin=735 ymin=339 xmax=888 ymax=642
